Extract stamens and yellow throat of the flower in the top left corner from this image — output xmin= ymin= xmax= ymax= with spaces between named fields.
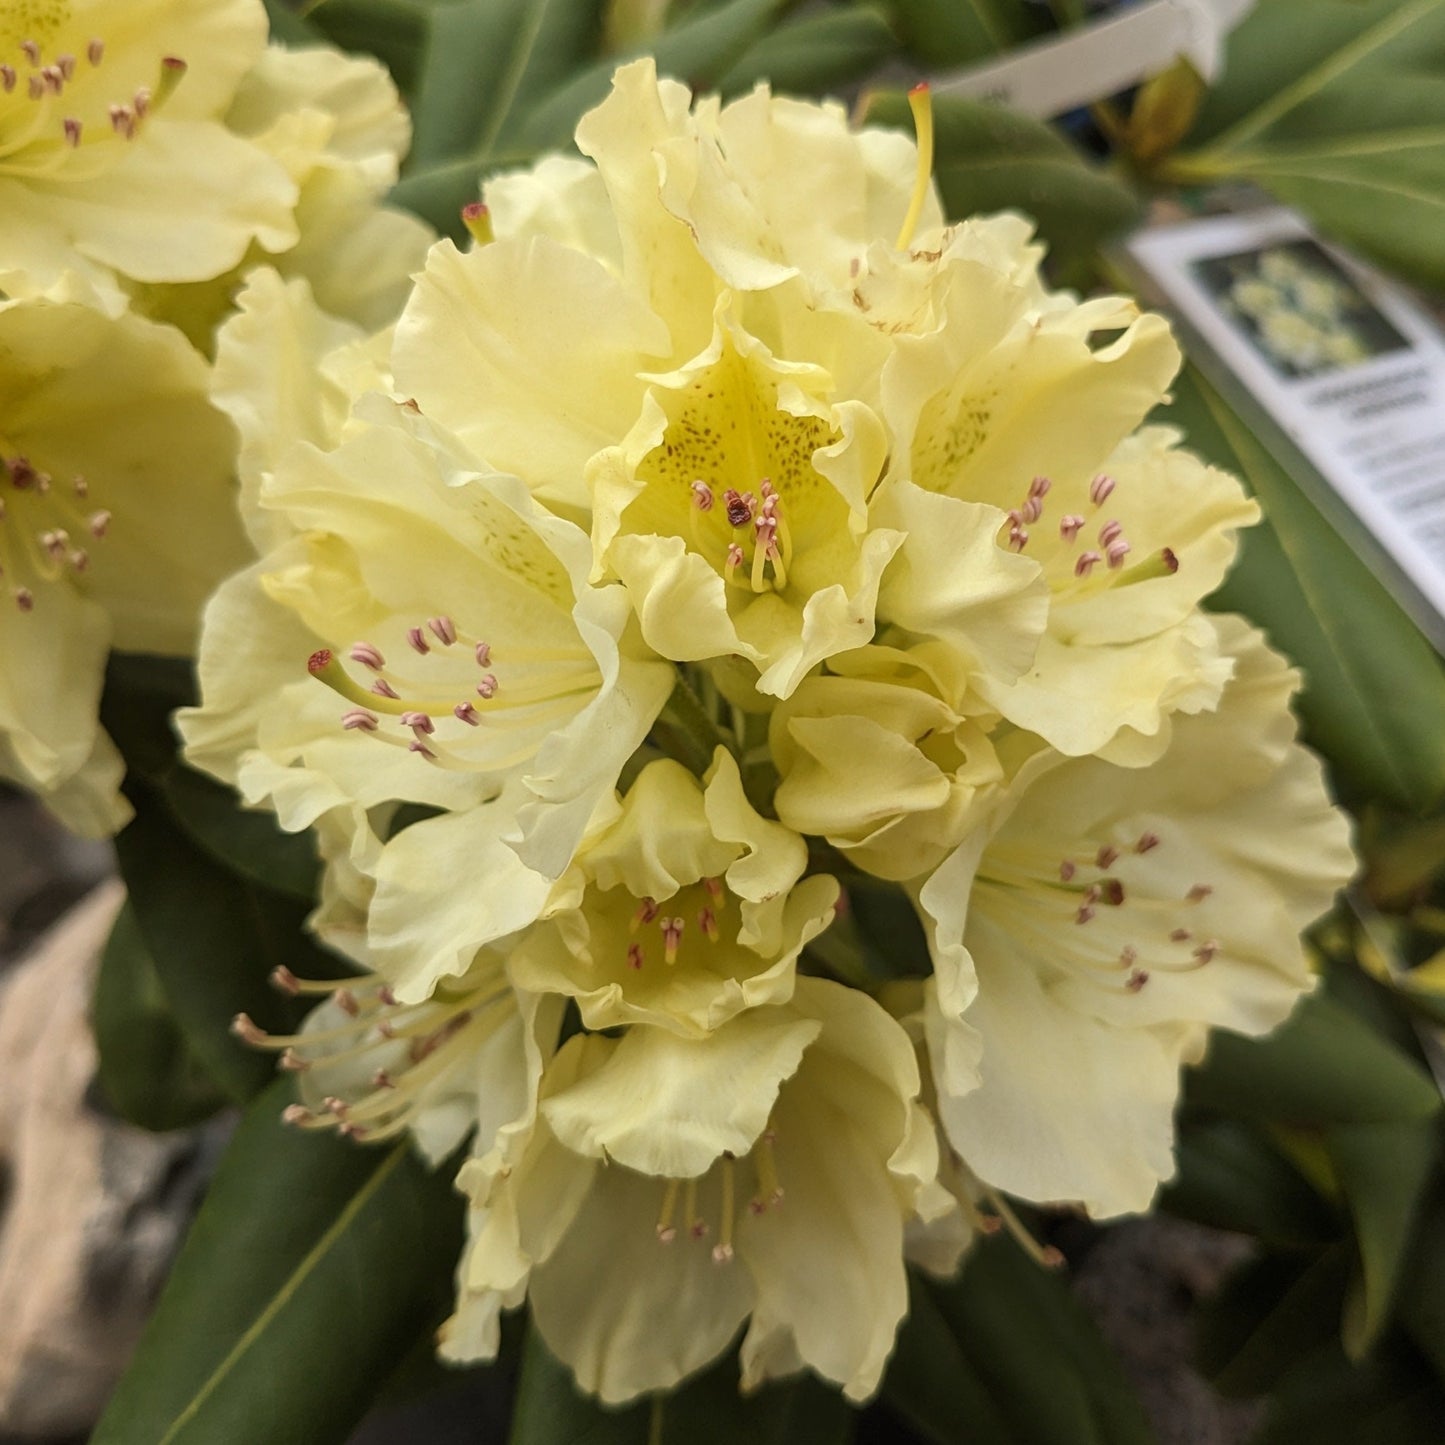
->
xmin=0 ymin=14 xmax=186 ymax=181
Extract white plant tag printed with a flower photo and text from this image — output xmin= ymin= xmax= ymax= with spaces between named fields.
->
xmin=1124 ymin=207 xmax=1445 ymax=650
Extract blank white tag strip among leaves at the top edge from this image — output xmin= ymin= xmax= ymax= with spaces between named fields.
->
xmin=931 ymin=0 xmax=1256 ymax=118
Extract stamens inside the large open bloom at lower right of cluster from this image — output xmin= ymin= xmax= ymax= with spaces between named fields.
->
xmin=975 ymin=831 xmax=1221 ymax=994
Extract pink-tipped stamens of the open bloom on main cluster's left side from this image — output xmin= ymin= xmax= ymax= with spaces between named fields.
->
xmin=306 ymin=616 xmax=601 ymax=767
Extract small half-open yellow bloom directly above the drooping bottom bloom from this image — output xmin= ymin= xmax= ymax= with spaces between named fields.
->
xmin=512 ymin=749 xmax=838 ymax=1036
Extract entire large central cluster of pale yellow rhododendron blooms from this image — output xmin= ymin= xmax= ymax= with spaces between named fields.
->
xmin=182 ymin=61 xmax=1353 ymax=1402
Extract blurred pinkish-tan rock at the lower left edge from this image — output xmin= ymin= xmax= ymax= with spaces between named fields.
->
xmin=0 ymin=881 xmax=218 ymax=1438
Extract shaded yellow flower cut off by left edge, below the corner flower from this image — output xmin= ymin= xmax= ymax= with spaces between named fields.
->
xmin=0 ymin=301 xmax=246 ymax=837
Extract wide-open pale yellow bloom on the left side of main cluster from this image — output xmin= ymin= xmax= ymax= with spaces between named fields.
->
xmin=182 ymin=396 xmax=672 ymax=1000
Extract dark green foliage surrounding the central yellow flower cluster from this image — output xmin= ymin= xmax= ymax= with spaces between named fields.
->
xmin=94 ymin=0 xmax=1445 ymax=1445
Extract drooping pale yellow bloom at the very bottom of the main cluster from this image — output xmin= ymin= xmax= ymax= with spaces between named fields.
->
xmin=444 ymin=978 xmax=949 ymax=1402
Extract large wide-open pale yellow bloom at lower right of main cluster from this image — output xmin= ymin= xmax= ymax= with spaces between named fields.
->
xmin=919 ymin=618 xmax=1354 ymax=1214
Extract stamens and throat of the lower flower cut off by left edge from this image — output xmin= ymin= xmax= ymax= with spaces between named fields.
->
xmin=0 ymin=450 xmax=110 ymax=613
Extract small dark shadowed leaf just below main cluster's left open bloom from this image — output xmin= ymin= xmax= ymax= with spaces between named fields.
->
xmin=162 ymin=764 xmax=321 ymax=903
